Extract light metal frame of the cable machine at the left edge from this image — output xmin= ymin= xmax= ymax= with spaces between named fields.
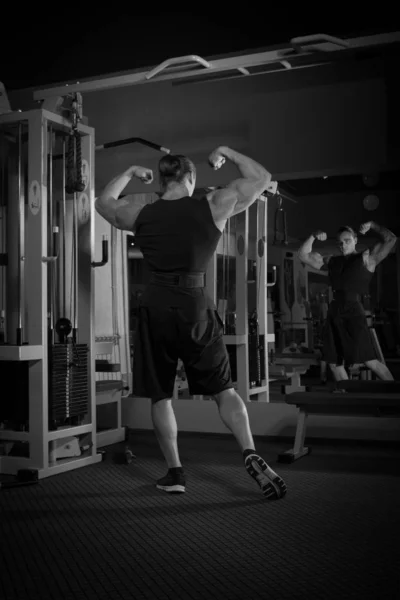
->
xmin=0 ymin=109 xmax=102 ymax=479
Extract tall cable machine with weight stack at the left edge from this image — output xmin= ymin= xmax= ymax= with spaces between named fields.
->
xmin=0 ymin=101 xmax=108 ymax=479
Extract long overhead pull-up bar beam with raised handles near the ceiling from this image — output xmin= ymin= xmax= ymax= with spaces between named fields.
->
xmin=33 ymin=31 xmax=400 ymax=101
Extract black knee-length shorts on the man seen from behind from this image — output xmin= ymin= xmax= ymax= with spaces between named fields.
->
xmin=132 ymin=286 xmax=233 ymax=401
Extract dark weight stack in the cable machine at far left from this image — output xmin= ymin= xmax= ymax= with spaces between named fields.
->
xmin=49 ymin=344 xmax=89 ymax=422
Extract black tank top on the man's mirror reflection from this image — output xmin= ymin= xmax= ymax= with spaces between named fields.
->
xmin=328 ymin=253 xmax=374 ymax=296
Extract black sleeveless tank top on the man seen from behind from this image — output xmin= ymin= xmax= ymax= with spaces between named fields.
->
xmin=135 ymin=196 xmax=222 ymax=273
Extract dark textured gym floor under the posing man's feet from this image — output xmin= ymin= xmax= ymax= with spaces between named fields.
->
xmin=0 ymin=432 xmax=400 ymax=600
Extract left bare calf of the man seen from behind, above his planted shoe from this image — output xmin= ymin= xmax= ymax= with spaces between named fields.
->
xmin=151 ymin=398 xmax=182 ymax=469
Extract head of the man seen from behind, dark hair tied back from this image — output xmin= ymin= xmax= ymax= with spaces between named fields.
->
xmin=158 ymin=154 xmax=196 ymax=196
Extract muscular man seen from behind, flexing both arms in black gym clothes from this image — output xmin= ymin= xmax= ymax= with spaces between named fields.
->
xmin=96 ymin=147 xmax=286 ymax=498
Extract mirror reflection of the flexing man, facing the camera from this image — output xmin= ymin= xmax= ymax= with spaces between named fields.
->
xmin=298 ymin=221 xmax=397 ymax=381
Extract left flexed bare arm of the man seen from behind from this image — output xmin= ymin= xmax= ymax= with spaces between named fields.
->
xmin=95 ymin=166 xmax=153 ymax=231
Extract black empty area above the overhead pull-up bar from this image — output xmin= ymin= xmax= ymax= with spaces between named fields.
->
xmin=0 ymin=7 xmax=396 ymax=90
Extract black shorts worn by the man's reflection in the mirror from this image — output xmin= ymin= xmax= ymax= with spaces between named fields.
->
xmin=323 ymin=300 xmax=378 ymax=365
